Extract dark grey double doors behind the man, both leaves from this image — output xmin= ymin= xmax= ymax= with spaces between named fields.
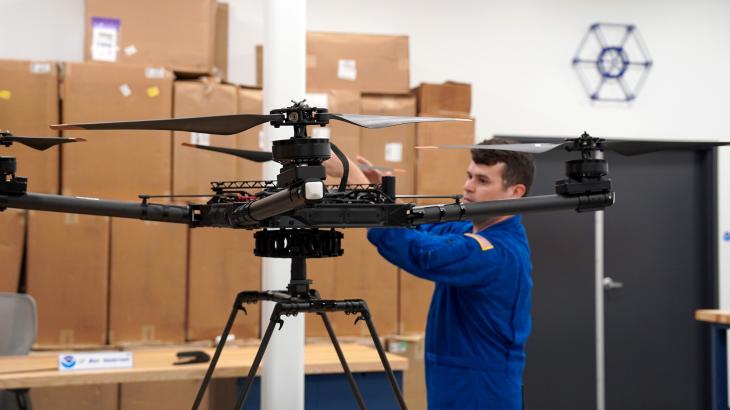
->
xmin=525 ymin=146 xmax=716 ymax=410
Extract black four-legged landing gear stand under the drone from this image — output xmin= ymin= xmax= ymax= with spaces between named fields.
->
xmin=193 ymin=243 xmax=406 ymax=410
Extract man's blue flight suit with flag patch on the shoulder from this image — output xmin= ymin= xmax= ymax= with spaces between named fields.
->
xmin=368 ymin=216 xmax=532 ymax=410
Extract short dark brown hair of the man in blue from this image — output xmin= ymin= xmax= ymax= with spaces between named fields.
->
xmin=471 ymin=138 xmax=535 ymax=196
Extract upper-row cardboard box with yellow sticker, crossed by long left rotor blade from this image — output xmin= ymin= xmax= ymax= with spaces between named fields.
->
xmin=61 ymin=61 xmax=172 ymax=200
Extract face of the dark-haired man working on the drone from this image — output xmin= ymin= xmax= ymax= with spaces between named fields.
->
xmin=464 ymin=161 xmax=525 ymax=202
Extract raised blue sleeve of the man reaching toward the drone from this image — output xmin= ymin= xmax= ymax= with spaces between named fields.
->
xmin=368 ymin=228 xmax=515 ymax=286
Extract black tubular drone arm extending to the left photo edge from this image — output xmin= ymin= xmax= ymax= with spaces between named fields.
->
xmin=0 ymin=193 xmax=192 ymax=224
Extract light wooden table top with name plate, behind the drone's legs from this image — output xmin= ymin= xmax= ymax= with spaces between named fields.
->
xmin=0 ymin=344 xmax=408 ymax=389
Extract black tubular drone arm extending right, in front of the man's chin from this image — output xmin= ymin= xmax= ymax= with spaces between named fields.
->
xmin=411 ymin=193 xmax=614 ymax=225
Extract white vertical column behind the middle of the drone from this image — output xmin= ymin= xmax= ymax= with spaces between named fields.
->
xmin=261 ymin=0 xmax=306 ymax=410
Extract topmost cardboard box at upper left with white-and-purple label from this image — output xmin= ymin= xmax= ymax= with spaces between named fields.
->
xmin=84 ymin=0 xmax=216 ymax=74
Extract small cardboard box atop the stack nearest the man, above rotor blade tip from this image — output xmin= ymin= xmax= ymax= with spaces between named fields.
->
xmin=413 ymin=81 xmax=471 ymax=118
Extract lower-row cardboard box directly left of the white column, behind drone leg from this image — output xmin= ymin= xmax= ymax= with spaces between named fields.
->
xmin=186 ymin=228 xmax=261 ymax=340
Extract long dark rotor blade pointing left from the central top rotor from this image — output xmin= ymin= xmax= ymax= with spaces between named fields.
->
xmin=51 ymin=114 xmax=283 ymax=135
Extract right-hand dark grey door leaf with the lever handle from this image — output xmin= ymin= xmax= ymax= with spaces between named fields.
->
xmin=605 ymin=151 xmax=716 ymax=410
